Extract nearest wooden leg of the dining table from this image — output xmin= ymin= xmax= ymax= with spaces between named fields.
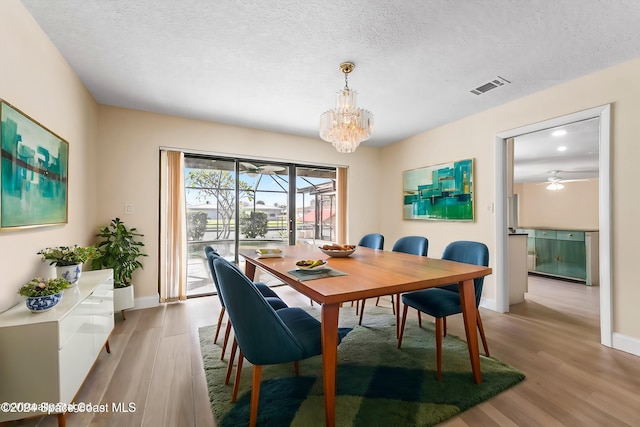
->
xmin=322 ymin=304 xmax=340 ymax=427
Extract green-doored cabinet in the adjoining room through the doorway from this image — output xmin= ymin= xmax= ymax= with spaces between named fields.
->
xmin=521 ymin=229 xmax=598 ymax=285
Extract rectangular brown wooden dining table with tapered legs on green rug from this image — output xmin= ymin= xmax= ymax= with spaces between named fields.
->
xmin=239 ymin=245 xmax=492 ymax=426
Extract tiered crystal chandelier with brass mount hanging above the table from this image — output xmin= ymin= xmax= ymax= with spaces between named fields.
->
xmin=320 ymin=62 xmax=373 ymax=153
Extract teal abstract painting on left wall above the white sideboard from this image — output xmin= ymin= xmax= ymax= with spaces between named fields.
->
xmin=0 ymin=100 xmax=69 ymax=231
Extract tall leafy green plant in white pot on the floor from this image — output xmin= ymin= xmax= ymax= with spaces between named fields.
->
xmin=91 ymin=218 xmax=147 ymax=318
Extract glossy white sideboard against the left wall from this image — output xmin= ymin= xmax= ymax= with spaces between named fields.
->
xmin=0 ymin=269 xmax=114 ymax=425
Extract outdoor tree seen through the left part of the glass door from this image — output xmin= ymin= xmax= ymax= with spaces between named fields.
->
xmin=186 ymin=169 xmax=253 ymax=240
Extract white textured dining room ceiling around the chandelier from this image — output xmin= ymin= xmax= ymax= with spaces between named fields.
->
xmin=22 ymin=0 xmax=640 ymax=179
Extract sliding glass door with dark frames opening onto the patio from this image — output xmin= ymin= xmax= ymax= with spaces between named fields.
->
xmin=184 ymin=155 xmax=336 ymax=296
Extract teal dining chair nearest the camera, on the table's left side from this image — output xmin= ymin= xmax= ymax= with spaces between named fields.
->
xmin=213 ymin=258 xmax=344 ymax=426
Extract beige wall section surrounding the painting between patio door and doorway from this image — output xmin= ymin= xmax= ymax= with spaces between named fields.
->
xmin=378 ymin=117 xmax=495 ymax=298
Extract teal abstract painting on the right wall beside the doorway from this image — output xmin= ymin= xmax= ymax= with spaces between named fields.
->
xmin=402 ymin=159 xmax=473 ymax=221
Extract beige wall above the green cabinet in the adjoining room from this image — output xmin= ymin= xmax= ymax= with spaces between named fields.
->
xmin=514 ymin=178 xmax=600 ymax=230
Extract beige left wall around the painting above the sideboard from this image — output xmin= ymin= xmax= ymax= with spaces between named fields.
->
xmin=0 ymin=0 xmax=97 ymax=311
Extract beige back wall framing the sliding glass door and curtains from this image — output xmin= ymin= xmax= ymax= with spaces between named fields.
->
xmin=97 ymin=106 xmax=379 ymax=297
